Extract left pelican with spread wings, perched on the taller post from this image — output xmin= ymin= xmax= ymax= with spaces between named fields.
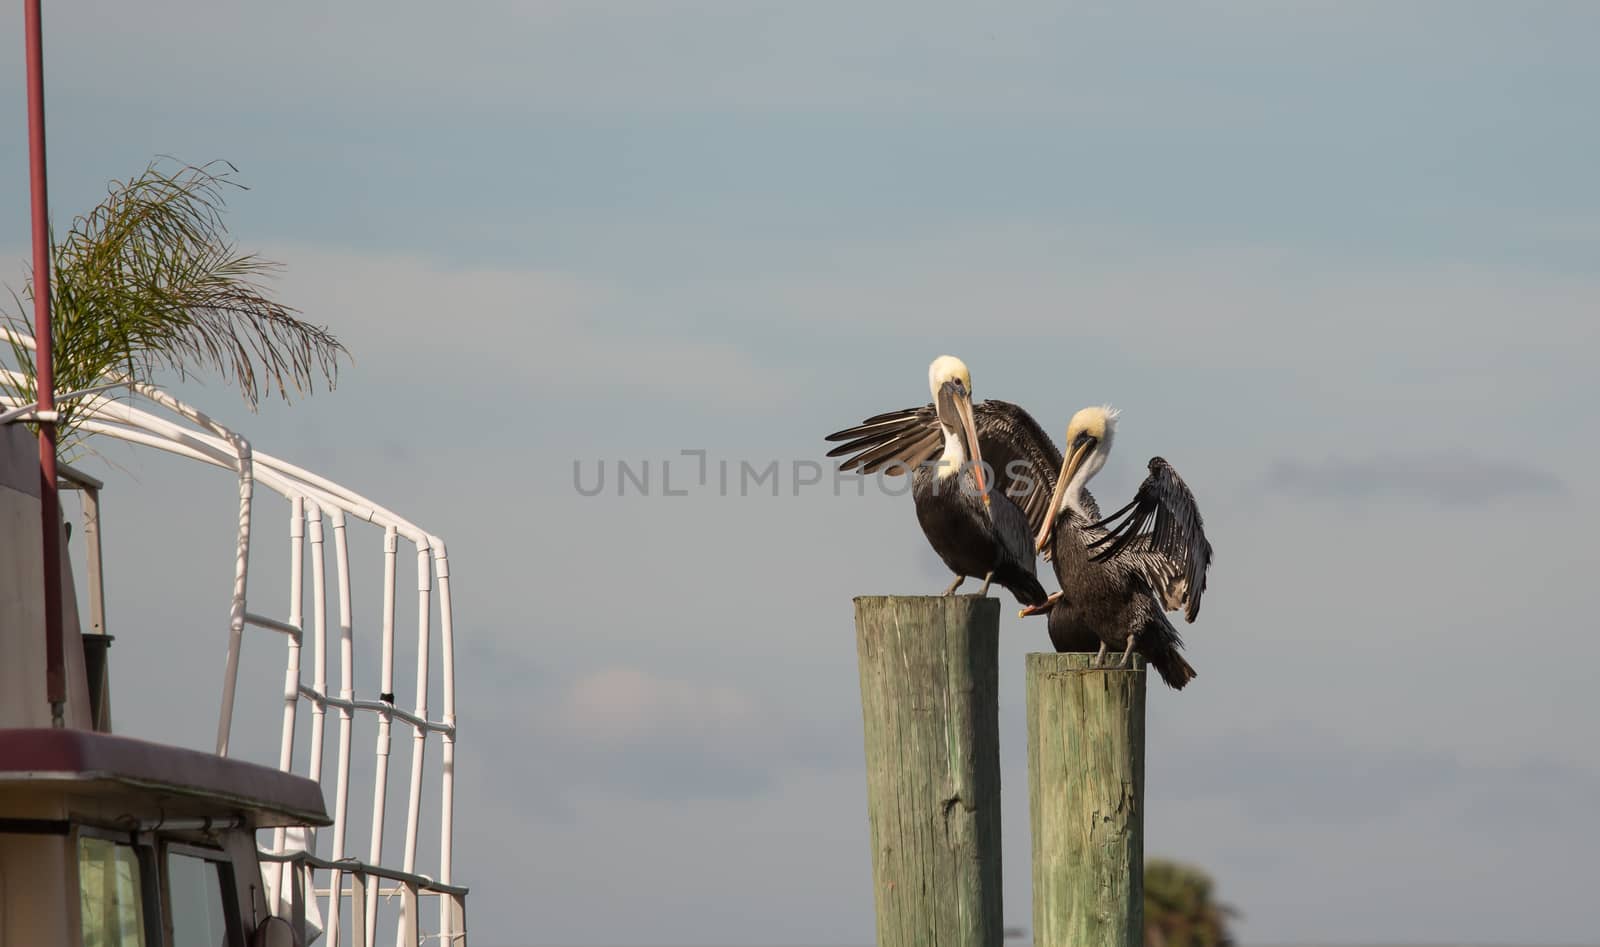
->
xmin=827 ymin=355 xmax=1061 ymax=606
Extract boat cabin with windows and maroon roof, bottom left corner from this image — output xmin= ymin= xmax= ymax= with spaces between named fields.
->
xmin=0 ymin=728 xmax=330 ymax=947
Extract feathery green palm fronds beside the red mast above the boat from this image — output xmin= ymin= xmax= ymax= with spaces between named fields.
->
xmin=0 ymin=162 xmax=349 ymax=445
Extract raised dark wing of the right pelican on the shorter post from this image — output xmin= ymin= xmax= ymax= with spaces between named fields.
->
xmin=1090 ymin=458 xmax=1211 ymax=622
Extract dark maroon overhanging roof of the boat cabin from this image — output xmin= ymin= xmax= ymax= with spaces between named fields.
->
xmin=0 ymin=728 xmax=331 ymax=827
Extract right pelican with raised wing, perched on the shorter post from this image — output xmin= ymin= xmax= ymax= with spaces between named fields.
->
xmin=1022 ymin=408 xmax=1211 ymax=689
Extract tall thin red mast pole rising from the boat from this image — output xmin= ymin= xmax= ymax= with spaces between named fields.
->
xmin=22 ymin=0 xmax=67 ymax=726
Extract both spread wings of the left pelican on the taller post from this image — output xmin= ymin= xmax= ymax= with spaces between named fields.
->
xmin=827 ymin=398 xmax=1061 ymax=534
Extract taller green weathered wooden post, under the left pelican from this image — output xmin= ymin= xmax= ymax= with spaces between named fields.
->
xmin=856 ymin=595 xmax=1003 ymax=947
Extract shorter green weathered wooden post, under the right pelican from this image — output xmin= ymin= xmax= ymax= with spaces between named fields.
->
xmin=1027 ymin=654 xmax=1146 ymax=947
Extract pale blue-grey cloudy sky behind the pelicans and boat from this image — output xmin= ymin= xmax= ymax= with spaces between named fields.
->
xmin=0 ymin=0 xmax=1600 ymax=945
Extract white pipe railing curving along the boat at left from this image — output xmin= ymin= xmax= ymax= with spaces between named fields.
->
xmin=0 ymin=328 xmax=466 ymax=947
